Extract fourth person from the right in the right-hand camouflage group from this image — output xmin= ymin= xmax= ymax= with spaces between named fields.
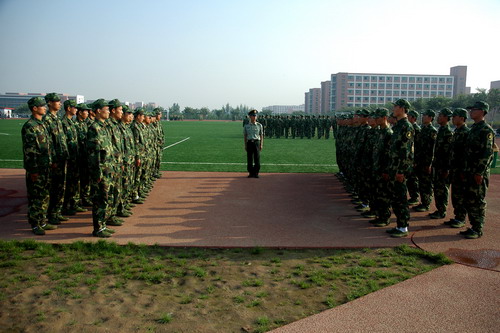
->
xmin=413 ymin=109 xmax=437 ymax=212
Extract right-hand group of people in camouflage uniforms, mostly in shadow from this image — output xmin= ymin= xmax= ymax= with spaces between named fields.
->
xmin=333 ymin=99 xmax=495 ymax=239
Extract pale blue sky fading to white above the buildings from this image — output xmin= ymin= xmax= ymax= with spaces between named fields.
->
xmin=0 ymin=0 xmax=500 ymax=109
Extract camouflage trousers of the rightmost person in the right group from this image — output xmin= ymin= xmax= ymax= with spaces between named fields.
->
xmin=465 ymin=175 xmax=489 ymax=231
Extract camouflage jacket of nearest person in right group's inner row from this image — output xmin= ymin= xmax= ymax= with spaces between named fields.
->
xmin=387 ymin=117 xmax=415 ymax=178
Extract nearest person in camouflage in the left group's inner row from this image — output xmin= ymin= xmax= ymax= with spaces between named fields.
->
xmin=87 ymin=99 xmax=115 ymax=238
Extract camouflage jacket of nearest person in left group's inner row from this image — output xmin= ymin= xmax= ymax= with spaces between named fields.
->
xmin=87 ymin=120 xmax=115 ymax=181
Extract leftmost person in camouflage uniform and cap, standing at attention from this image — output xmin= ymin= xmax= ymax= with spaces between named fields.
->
xmin=21 ymin=97 xmax=57 ymax=235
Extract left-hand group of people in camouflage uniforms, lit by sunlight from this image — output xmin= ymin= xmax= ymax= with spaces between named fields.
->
xmin=22 ymin=93 xmax=164 ymax=238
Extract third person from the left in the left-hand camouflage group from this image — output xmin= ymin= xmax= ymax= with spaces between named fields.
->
xmin=61 ymin=100 xmax=87 ymax=215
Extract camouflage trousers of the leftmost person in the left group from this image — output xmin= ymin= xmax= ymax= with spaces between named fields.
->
xmin=26 ymin=170 xmax=50 ymax=228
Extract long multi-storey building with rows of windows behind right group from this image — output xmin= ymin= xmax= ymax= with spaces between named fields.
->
xmin=329 ymin=66 xmax=468 ymax=111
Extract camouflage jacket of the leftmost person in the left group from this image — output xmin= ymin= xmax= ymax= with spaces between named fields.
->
xmin=21 ymin=116 xmax=52 ymax=174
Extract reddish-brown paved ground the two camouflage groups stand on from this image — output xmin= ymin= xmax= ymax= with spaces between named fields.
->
xmin=0 ymin=169 xmax=500 ymax=332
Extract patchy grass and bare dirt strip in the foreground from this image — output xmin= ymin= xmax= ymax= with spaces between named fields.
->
xmin=0 ymin=240 xmax=451 ymax=332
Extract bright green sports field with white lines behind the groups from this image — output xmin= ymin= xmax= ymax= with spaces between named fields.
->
xmin=0 ymin=119 xmax=338 ymax=173
